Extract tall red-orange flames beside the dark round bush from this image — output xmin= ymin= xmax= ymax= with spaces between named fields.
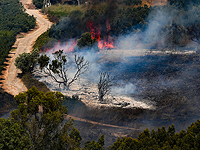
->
xmin=87 ymin=20 xmax=116 ymax=49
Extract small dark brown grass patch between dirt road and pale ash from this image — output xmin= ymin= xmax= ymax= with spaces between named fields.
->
xmin=21 ymin=73 xmax=50 ymax=93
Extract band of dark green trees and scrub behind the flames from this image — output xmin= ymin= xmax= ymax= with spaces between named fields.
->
xmin=32 ymin=0 xmax=200 ymax=50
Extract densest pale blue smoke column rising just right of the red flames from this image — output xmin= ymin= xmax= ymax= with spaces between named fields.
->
xmin=116 ymin=9 xmax=172 ymax=50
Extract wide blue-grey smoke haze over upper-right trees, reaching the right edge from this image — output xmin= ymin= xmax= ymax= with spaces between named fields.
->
xmin=116 ymin=4 xmax=200 ymax=52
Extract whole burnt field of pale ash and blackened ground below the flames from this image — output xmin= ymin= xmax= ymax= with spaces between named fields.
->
xmin=32 ymin=50 xmax=200 ymax=147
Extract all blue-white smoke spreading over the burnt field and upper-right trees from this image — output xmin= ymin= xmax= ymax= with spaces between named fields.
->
xmin=35 ymin=2 xmax=200 ymax=113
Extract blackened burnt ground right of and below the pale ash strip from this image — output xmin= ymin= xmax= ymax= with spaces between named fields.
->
xmin=66 ymin=54 xmax=200 ymax=147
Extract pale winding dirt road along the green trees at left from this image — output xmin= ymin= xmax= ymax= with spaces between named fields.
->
xmin=0 ymin=0 xmax=52 ymax=96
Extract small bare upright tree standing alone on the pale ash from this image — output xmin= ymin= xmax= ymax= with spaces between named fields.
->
xmin=98 ymin=72 xmax=113 ymax=102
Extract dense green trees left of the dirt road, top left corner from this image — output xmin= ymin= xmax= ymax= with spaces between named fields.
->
xmin=0 ymin=0 xmax=36 ymax=72
